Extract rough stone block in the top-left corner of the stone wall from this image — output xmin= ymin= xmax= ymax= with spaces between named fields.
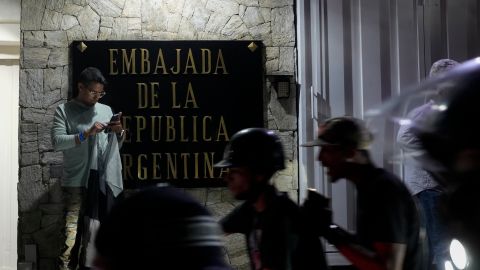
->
xmin=20 ymin=0 xmax=46 ymax=30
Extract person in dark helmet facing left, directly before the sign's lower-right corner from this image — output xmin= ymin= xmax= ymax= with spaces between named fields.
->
xmin=214 ymin=128 xmax=327 ymax=270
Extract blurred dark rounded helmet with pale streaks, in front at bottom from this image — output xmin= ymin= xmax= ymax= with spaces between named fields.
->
xmin=94 ymin=187 xmax=231 ymax=270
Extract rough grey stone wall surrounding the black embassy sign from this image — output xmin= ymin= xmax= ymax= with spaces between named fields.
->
xmin=18 ymin=0 xmax=298 ymax=270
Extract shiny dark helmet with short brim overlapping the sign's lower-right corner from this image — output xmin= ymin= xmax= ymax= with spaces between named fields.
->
xmin=214 ymin=128 xmax=285 ymax=173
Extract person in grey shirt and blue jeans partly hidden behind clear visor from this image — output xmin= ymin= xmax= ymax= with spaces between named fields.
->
xmin=397 ymin=59 xmax=459 ymax=269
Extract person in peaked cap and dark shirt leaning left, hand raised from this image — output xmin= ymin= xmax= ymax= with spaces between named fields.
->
xmin=302 ymin=117 xmax=426 ymax=270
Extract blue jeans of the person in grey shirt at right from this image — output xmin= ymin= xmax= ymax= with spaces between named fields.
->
xmin=415 ymin=189 xmax=449 ymax=266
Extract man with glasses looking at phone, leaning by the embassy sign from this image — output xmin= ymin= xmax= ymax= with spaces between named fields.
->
xmin=52 ymin=67 xmax=124 ymax=269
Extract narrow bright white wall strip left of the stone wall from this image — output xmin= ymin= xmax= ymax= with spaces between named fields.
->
xmin=0 ymin=0 xmax=20 ymax=270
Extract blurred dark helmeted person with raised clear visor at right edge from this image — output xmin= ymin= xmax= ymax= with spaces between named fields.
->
xmin=374 ymin=58 xmax=480 ymax=269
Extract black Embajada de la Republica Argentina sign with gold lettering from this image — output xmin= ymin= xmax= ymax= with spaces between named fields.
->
xmin=71 ymin=41 xmax=264 ymax=188
